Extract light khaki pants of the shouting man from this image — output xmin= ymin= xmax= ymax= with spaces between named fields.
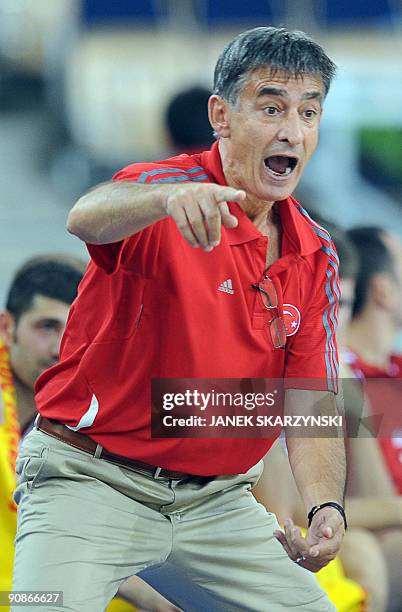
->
xmin=13 ymin=429 xmax=335 ymax=612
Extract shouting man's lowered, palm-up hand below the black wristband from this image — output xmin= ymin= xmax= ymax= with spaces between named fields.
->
xmin=274 ymin=507 xmax=345 ymax=572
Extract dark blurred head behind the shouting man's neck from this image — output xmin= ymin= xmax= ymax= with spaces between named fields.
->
xmin=165 ymin=86 xmax=214 ymax=154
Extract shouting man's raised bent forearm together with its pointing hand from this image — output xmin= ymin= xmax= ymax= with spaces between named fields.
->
xmin=67 ymin=181 xmax=246 ymax=252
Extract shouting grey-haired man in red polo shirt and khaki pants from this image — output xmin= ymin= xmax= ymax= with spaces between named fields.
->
xmin=14 ymin=28 xmax=346 ymax=612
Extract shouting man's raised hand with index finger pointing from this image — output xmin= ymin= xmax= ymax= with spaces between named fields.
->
xmin=165 ymin=183 xmax=246 ymax=252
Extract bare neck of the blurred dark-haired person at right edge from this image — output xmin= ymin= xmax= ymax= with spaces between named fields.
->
xmin=347 ymin=309 xmax=396 ymax=369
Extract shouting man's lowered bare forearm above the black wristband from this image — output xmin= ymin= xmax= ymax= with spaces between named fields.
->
xmin=286 ymin=390 xmax=346 ymax=512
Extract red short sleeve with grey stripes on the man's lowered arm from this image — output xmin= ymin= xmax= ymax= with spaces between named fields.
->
xmin=285 ymin=244 xmax=340 ymax=393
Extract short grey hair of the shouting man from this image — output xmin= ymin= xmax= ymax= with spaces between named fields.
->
xmin=213 ymin=27 xmax=336 ymax=106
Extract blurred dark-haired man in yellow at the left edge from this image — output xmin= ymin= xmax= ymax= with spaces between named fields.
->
xmin=0 ymin=255 xmax=85 ymax=591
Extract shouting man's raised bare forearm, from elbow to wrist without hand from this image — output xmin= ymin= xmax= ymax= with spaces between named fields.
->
xmin=67 ymin=181 xmax=166 ymax=244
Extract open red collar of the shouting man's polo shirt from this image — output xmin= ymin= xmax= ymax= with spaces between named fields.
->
xmin=200 ymin=142 xmax=321 ymax=256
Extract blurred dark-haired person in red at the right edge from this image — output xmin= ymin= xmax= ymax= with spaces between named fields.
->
xmin=345 ymin=227 xmax=402 ymax=612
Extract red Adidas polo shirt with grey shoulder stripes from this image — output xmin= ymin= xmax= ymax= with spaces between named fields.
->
xmin=36 ymin=144 xmax=339 ymax=475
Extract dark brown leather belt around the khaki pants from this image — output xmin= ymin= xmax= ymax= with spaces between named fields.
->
xmin=36 ymin=416 xmax=194 ymax=480
